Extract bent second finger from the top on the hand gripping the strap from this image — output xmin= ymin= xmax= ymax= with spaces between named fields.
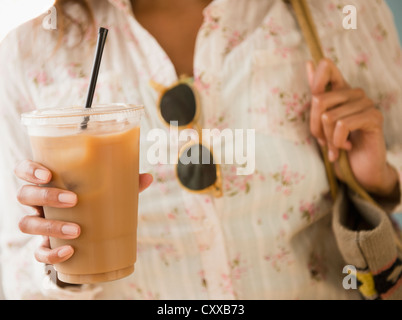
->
xmin=310 ymin=89 xmax=365 ymax=145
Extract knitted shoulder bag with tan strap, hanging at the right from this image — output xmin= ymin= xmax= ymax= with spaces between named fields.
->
xmin=288 ymin=0 xmax=402 ymax=300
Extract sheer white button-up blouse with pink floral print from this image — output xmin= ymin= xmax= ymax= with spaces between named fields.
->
xmin=0 ymin=0 xmax=402 ymax=299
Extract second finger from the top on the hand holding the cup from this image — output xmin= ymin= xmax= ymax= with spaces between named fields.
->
xmin=17 ymin=185 xmax=78 ymax=208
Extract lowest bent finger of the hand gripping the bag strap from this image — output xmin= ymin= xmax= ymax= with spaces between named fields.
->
xmin=333 ymin=107 xmax=384 ymax=152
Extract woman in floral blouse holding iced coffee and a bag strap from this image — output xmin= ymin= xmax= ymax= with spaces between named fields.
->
xmin=0 ymin=0 xmax=402 ymax=299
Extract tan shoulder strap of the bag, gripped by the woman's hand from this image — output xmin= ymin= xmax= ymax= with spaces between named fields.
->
xmin=290 ymin=0 xmax=379 ymax=207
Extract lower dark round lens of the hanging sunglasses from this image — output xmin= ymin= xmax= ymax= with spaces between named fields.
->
xmin=177 ymin=144 xmax=217 ymax=191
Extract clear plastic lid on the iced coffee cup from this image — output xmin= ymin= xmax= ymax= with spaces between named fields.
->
xmin=21 ymin=104 xmax=144 ymax=127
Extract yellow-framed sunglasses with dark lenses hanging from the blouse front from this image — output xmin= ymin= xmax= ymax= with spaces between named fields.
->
xmin=150 ymin=77 xmax=222 ymax=198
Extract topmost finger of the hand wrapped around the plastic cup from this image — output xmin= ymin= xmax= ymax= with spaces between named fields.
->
xmin=14 ymin=160 xmax=52 ymax=184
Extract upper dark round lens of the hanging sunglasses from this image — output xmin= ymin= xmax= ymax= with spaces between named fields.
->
xmin=160 ymin=84 xmax=196 ymax=126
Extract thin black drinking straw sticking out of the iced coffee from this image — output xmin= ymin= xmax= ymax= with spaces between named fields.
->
xmin=81 ymin=28 xmax=109 ymax=130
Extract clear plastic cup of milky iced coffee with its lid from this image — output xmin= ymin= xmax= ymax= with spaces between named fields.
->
xmin=23 ymin=105 xmax=142 ymax=283
